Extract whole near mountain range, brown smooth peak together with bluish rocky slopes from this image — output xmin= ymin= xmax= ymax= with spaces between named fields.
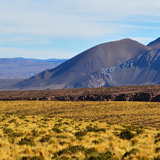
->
xmin=2 ymin=38 xmax=160 ymax=90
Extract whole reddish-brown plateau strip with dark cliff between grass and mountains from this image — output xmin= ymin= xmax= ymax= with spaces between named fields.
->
xmin=0 ymin=85 xmax=160 ymax=102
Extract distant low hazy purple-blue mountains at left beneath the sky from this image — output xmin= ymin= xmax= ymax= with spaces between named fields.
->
xmin=0 ymin=58 xmax=66 ymax=79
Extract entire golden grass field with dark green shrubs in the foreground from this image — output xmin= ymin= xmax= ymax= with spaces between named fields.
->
xmin=0 ymin=101 xmax=160 ymax=160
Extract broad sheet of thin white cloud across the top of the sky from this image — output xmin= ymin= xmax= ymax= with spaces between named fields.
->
xmin=0 ymin=0 xmax=160 ymax=37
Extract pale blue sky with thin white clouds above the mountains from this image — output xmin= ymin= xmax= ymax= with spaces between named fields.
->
xmin=0 ymin=0 xmax=160 ymax=59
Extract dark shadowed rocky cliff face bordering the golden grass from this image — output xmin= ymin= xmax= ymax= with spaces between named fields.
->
xmin=0 ymin=92 xmax=160 ymax=102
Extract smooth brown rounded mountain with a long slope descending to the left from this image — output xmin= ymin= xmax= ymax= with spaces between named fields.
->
xmin=12 ymin=39 xmax=151 ymax=90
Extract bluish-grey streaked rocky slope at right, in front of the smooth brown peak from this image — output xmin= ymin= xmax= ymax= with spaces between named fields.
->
xmin=75 ymin=50 xmax=160 ymax=88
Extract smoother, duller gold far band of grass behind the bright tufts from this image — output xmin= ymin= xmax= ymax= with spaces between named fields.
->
xmin=0 ymin=101 xmax=160 ymax=128
